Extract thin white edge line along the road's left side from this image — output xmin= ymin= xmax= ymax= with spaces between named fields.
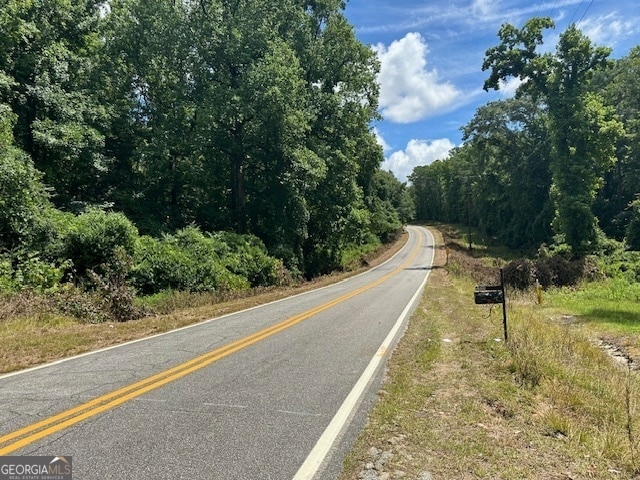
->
xmin=0 ymin=227 xmax=410 ymax=380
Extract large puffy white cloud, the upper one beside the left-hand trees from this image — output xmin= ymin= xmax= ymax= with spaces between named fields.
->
xmin=374 ymin=33 xmax=461 ymax=123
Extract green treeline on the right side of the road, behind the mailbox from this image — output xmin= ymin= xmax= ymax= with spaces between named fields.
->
xmin=411 ymin=18 xmax=640 ymax=257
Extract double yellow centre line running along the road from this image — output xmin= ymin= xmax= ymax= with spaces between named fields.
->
xmin=0 ymin=228 xmax=422 ymax=456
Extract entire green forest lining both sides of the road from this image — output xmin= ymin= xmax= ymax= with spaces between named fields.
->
xmin=0 ymin=0 xmax=640 ymax=319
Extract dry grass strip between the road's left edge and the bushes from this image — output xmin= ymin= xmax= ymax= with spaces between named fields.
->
xmin=0 ymin=234 xmax=407 ymax=373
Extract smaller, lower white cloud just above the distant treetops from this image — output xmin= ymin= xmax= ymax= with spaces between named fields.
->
xmin=382 ymin=138 xmax=455 ymax=182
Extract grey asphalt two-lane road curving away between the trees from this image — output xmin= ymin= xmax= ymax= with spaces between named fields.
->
xmin=0 ymin=227 xmax=434 ymax=480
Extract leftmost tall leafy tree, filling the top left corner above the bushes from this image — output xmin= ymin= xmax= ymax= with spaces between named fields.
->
xmin=0 ymin=0 xmax=107 ymax=206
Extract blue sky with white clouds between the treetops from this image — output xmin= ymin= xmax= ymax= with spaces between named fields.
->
xmin=345 ymin=0 xmax=640 ymax=181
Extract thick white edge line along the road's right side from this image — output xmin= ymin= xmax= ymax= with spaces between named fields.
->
xmin=293 ymin=226 xmax=435 ymax=480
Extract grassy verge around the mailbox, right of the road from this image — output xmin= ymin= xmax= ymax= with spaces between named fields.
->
xmin=341 ymin=228 xmax=640 ymax=480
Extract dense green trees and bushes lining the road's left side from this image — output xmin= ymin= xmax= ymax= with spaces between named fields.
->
xmin=0 ymin=0 xmax=413 ymax=292
